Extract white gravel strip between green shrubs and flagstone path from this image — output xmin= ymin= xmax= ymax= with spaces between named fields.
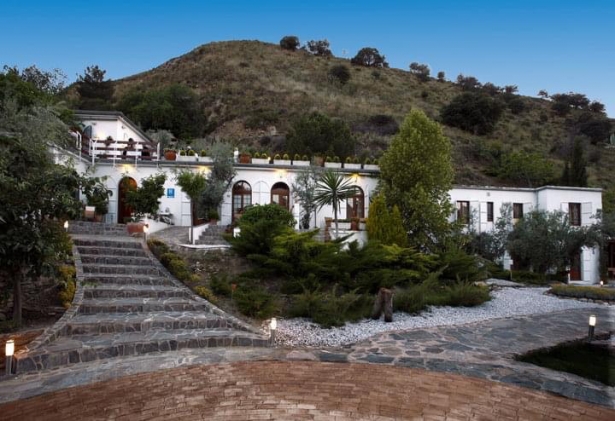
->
xmin=276 ymin=288 xmax=601 ymax=347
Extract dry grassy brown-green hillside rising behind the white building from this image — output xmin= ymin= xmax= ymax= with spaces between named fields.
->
xmin=114 ymin=41 xmax=615 ymax=201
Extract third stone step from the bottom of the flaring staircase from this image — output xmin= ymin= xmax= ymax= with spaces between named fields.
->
xmin=79 ymin=297 xmax=209 ymax=314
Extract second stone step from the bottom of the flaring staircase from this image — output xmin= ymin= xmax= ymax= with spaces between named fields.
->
xmin=63 ymin=311 xmax=233 ymax=336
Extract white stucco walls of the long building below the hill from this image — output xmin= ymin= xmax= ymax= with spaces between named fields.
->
xmin=56 ymin=133 xmax=602 ymax=283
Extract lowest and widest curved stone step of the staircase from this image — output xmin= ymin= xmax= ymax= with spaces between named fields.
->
xmin=16 ymin=329 xmax=269 ymax=373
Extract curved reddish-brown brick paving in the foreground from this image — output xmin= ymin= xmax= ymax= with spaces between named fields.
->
xmin=0 ymin=361 xmax=615 ymax=421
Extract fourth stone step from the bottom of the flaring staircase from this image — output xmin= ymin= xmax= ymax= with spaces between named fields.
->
xmin=83 ymin=284 xmax=191 ymax=299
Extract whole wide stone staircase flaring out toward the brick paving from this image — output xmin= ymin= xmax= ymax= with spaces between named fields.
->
xmin=16 ymin=224 xmax=269 ymax=373
